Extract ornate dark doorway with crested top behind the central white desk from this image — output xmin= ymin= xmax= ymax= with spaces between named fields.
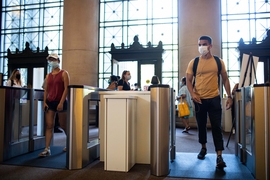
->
xmin=109 ymin=36 xmax=164 ymax=90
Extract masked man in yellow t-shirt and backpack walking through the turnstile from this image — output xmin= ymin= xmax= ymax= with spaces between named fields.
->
xmin=186 ymin=36 xmax=233 ymax=169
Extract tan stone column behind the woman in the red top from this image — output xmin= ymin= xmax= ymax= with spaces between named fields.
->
xmin=62 ymin=0 xmax=99 ymax=86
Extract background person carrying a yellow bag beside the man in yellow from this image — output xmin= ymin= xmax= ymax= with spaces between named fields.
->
xmin=177 ymin=77 xmax=193 ymax=133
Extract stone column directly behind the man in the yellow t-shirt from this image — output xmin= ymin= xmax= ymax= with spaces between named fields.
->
xmin=178 ymin=0 xmax=221 ymax=79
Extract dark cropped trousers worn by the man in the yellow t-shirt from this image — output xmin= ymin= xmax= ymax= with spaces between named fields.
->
xmin=194 ymin=96 xmax=224 ymax=151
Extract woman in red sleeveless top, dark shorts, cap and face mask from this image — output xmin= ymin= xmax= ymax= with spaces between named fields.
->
xmin=39 ymin=54 xmax=69 ymax=157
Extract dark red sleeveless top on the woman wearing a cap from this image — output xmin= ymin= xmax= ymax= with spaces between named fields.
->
xmin=47 ymin=70 xmax=65 ymax=102
